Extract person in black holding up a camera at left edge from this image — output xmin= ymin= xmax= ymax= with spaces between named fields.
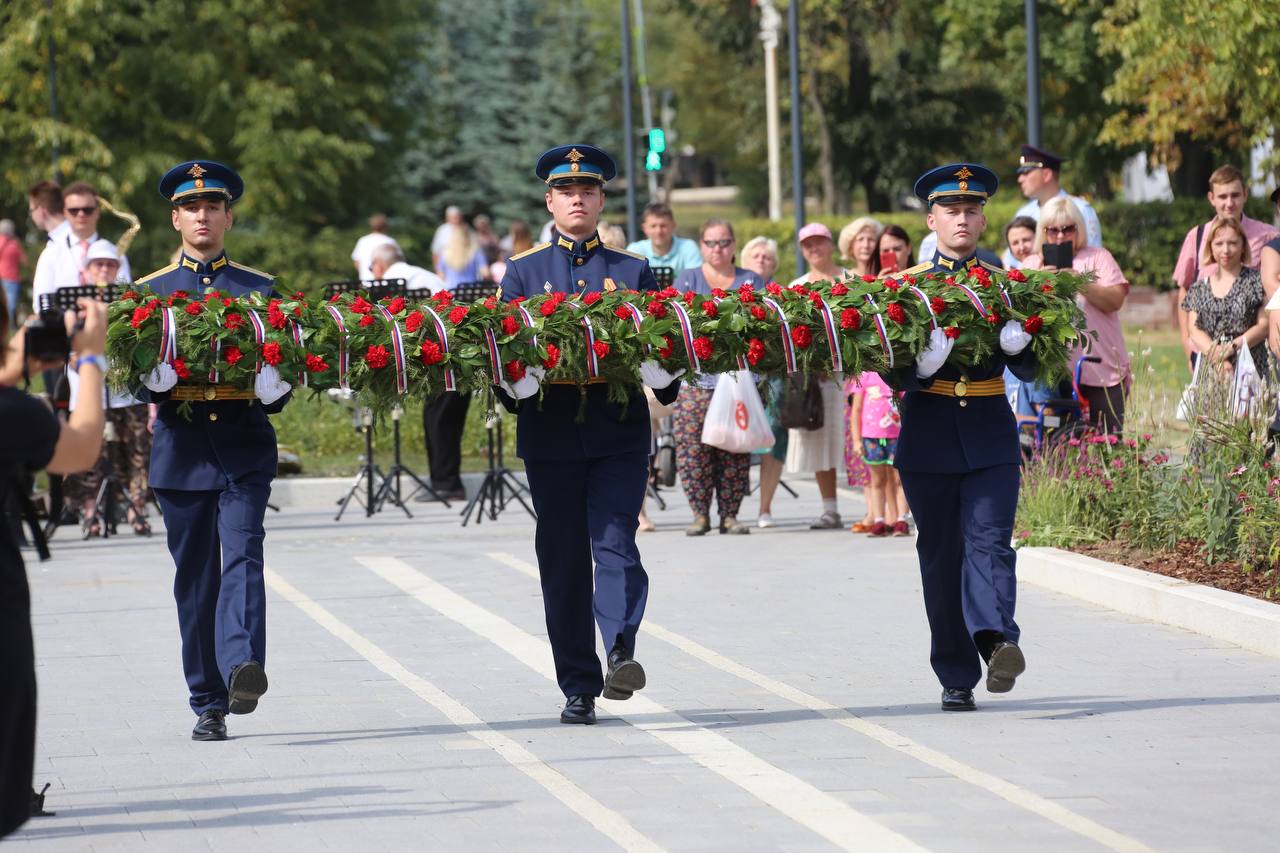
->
xmin=0 ymin=300 xmax=106 ymax=838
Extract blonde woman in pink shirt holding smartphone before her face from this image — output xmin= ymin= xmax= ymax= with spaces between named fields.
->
xmin=1023 ymin=196 xmax=1130 ymax=433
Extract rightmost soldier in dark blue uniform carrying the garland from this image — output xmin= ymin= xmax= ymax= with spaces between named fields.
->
xmin=895 ymin=163 xmax=1036 ymax=711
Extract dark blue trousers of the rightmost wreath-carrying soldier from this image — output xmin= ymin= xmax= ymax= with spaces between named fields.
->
xmin=899 ymin=465 xmax=1020 ymax=689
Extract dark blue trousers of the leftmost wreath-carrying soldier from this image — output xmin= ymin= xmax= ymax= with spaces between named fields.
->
xmin=155 ymin=482 xmax=271 ymax=713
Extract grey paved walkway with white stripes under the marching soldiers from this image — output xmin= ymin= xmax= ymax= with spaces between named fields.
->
xmin=6 ymin=473 xmax=1280 ymax=853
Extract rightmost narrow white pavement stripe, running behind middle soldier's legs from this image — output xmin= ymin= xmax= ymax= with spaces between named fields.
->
xmin=488 ymin=552 xmax=1151 ymax=853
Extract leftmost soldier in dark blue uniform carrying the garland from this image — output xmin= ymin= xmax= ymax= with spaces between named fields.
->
xmin=137 ymin=160 xmax=289 ymax=740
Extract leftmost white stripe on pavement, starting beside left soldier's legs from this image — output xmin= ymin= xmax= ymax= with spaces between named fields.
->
xmin=265 ymin=569 xmax=663 ymax=853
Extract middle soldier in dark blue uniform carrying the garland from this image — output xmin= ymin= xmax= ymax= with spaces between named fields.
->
xmin=502 ymin=145 xmax=680 ymax=724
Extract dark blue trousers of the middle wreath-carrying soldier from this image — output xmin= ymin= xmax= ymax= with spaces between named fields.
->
xmin=525 ymin=452 xmax=649 ymax=697
